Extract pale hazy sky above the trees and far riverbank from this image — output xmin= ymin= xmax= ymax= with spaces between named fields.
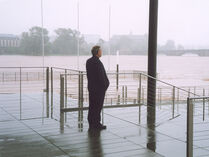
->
xmin=0 ymin=0 xmax=209 ymax=48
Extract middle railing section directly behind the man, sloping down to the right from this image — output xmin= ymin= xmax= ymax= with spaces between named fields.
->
xmin=59 ymin=71 xmax=207 ymax=125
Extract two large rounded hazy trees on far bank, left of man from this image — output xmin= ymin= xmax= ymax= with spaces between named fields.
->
xmin=19 ymin=26 xmax=90 ymax=55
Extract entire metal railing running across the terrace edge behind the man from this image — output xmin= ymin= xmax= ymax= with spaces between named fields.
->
xmin=0 ymin=67 xmax=209 ymax=157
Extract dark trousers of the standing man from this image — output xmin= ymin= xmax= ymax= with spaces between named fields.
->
xmin=88 ymin=92 xmax=105 ymax=125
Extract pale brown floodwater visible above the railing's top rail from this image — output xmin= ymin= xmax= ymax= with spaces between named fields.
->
xmin=0 ymin=55 xmax=209 ymax=86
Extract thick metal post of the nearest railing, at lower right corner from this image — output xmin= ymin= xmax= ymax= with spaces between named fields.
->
xmin=187 ymin=98 xmax=193 ymax=157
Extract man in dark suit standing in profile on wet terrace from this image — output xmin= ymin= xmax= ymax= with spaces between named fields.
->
xmin=86 ymin=46 xmax=110 ymax=130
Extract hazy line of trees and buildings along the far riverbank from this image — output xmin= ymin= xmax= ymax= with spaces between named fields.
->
xmin=0 ymin=26 xmax=183 ymax=56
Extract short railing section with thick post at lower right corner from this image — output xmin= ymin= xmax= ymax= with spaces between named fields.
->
xmin=186 ymin=97 xmax=209 ymax=157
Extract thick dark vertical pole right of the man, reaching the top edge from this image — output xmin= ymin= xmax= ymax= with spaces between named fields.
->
xmin=147 ymin=0 xmax=158 ymax=129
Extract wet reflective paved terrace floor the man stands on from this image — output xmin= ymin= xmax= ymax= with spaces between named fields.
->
xmin=0 ymin=93 xmax=209 ymax=157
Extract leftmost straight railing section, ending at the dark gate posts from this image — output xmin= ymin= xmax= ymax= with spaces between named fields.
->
xmin=0 ymin=67 xmax=49 ymax=120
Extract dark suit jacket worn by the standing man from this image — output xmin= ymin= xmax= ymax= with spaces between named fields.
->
xmin=86 ymin=56 xmax=110 ymax=93
